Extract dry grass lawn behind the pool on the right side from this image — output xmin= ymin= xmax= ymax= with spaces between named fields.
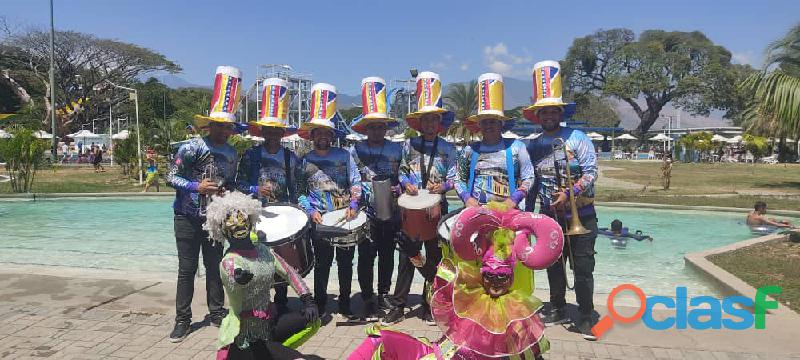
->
xmin=596 ymin=161 xmax=800 ymax=210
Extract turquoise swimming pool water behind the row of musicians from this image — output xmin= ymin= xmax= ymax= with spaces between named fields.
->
xmin=0 ymin=198 xmax=792 ymax=296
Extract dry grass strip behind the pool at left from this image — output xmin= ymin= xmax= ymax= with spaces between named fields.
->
xmin=0 ymin=166 xmax=172 ymax=193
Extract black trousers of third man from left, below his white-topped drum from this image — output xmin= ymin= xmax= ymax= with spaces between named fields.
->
xmin=312 ymin=234 xmax=356 ymax=308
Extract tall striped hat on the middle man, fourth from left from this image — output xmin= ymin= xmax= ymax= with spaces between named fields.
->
xmin=350 ymin=76 xmax=397 ymax=134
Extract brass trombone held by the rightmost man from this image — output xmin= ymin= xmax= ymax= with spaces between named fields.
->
xmin=553 ymin=137 xmax=591 ymax=290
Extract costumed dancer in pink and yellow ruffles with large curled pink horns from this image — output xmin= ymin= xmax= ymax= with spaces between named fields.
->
xmin=349 ymin=203 xmax=564 ymax=360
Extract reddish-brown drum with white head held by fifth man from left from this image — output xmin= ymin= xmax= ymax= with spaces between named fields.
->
xmin=397 ymin=189 xmax=442 ymax=241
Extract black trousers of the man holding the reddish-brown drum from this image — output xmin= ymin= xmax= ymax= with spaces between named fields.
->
xmin=394 ymin=233 xmax=442 ymax=306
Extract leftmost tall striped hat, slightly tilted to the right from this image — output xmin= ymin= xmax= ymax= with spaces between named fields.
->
xmin=194 ymin=66 xmax=242 ymax=128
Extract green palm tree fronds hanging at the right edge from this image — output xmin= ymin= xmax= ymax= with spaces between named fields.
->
xmin=741 ymin=24 xmax=800 ymax=139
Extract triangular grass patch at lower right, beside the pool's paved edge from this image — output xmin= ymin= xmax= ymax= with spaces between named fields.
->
xmin=708 ymin=236 xmax=800 ymax=311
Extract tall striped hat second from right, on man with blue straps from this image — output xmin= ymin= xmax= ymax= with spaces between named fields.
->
xmin=464 ymin=73 xmax=514 ymax=132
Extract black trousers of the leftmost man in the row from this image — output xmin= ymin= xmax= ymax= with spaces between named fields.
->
xmin=174 ymin=215 xmax=225 ymax=322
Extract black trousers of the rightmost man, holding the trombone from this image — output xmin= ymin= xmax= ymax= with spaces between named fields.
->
xmin=547 ymin=216 xmax=597 ymax=317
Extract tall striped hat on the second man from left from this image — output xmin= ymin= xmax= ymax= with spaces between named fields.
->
xmin=248 ymin=78 xmax=297 ymax=136
